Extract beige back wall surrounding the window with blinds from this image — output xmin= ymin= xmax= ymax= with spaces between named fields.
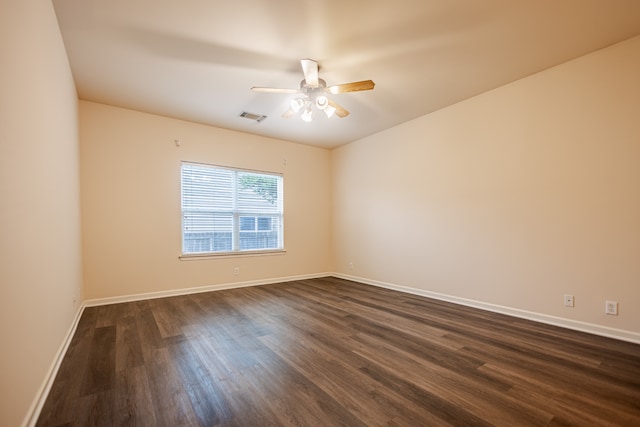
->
xmin=80 ymin=101 xmax=331 ymax=299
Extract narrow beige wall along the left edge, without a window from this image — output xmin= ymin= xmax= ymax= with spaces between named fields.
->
xmin=0 ymin=0 xmax=82 ymax=426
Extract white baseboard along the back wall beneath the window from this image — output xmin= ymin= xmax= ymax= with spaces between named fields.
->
xmin=83 ymin=273 xmax=332 ymax=307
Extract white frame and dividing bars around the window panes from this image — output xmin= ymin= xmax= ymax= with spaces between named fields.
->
xmin=180 ymin=161 xmax=285 ymax=259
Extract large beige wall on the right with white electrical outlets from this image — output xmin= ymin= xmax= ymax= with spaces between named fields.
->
xmin=333 ymin=37 xmax=640 ymax=338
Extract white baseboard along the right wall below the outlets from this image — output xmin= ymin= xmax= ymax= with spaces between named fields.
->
xmin=332 ymin=273 xmax=640 ymax=344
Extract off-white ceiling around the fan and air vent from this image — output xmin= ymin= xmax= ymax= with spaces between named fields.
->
xmin=53 ymin=0 xmax=640 ymax=147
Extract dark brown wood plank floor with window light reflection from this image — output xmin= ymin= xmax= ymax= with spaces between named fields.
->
xmin=38 ymin=278 xmax=640 ymax=426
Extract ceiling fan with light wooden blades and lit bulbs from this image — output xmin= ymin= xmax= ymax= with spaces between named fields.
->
xmin=251 ymin=59 xmax=375 ymax=122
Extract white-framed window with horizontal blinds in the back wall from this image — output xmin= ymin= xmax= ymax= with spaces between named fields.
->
xmin=181 ymin=163 xmax=284 ymax=255
